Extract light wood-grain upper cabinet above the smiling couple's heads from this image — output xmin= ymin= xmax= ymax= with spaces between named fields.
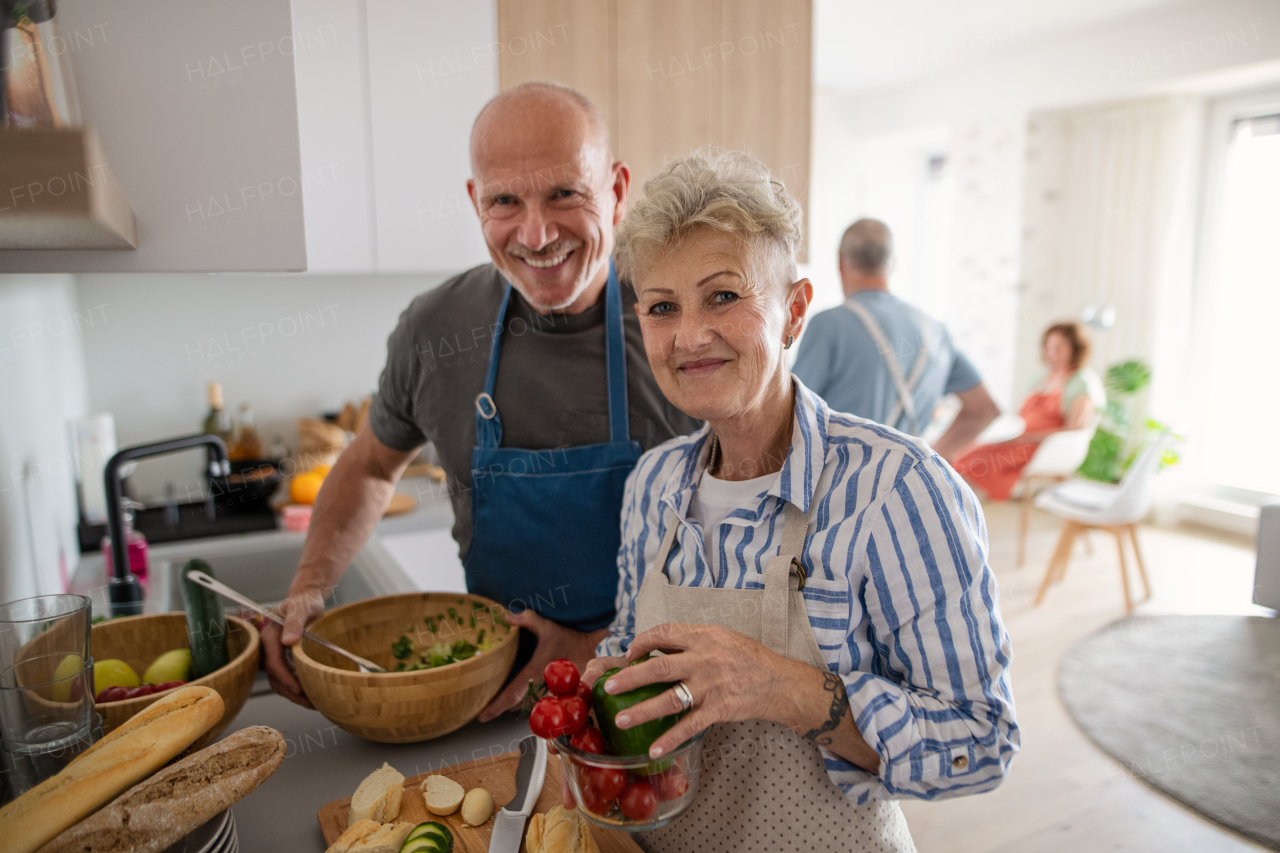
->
xmin=498 ymin=0 xmax=813 ymax=253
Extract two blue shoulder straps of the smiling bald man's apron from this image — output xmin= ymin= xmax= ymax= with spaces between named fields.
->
xmin=475 ymin=257 xmax=631 ymax=447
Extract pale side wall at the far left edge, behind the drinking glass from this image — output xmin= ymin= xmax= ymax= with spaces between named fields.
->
xmin=0 ymin=275 xmax=88 ymax=601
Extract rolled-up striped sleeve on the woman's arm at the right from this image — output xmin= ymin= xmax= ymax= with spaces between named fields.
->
xmin=828 ymin=456 xmax=1020 ymax=799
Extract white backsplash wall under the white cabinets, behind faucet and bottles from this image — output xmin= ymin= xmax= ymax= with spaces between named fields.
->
xmin=77 ymin=274 xmax=442 ymax=500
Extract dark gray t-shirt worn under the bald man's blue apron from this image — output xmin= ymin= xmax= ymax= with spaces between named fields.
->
xmin=369 ymin=264 xmax=701 ymax=555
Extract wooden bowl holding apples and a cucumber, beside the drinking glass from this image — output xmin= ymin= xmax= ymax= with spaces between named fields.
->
xmin=92 ymin=612 xmax=259 ymax=743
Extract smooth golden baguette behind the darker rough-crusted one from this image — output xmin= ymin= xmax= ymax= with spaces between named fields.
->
xmin=0 ymin=686 xmax=223 ymax=853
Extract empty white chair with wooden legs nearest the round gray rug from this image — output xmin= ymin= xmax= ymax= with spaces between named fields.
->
xmin=1036 ymin=430 xmax=1170 ymax=613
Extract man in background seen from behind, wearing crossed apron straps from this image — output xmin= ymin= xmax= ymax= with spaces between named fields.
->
xmin=794 ymin=219 xmax=1000 ymax=460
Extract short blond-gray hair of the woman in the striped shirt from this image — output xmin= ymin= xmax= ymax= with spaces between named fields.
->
xmin=617 ymin=147 xmax=803 ymax=287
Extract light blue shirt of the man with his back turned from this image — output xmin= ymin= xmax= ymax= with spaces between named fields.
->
xmin=792 ymin=291 xmax=982 ymax=432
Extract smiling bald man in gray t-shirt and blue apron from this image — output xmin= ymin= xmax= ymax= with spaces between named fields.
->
xmin=262 ymin=83 xmax=699 ymax=721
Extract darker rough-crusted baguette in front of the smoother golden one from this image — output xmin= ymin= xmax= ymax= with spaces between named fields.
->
xmin=40 ymin=726 xmax=285 ymax=853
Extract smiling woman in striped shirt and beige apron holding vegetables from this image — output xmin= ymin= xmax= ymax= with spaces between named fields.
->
xmin=584 ymin=151 xmax=1020 ymax=853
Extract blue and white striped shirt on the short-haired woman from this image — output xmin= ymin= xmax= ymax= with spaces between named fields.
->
xmin=598 ymin=379 xmax=1021 ymax=804
